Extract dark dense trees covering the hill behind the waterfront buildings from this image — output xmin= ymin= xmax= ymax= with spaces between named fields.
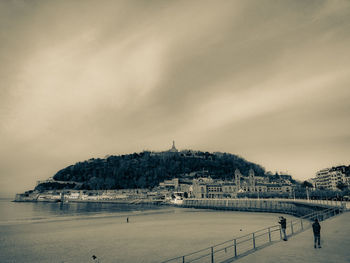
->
xmin=37 ymin=151 xmax=265 ymax=190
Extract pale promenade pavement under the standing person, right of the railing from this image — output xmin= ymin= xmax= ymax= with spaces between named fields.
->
xmin=234 ymin=212 xmax=350 ymax=263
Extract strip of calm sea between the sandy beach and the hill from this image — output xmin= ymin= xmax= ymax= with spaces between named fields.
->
xmin=0 ymin=199 xmax=160 ymax=222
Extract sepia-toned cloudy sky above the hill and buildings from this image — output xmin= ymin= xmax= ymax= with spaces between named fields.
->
xmin=0 ymin=0 xmax=350 ymax=194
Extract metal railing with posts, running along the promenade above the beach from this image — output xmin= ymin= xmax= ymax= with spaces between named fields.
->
xmin=162 ymin=207 xmax=343 ymax=263
